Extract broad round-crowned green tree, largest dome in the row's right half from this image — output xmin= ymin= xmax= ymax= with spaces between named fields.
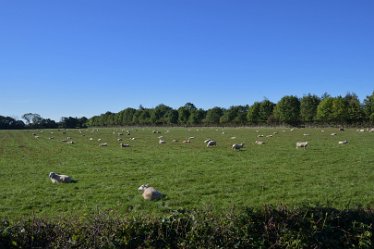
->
xmin=274 ymin=96 xmax=300 ymax=125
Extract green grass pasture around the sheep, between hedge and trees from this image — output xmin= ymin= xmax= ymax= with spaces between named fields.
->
xmin=0 ymin=128 xmax=374 ymax=218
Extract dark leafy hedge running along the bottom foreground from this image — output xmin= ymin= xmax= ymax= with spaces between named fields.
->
xmin=0 ymin=207 xmax=374 ymax=248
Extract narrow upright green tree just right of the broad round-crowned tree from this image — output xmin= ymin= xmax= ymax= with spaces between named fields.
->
xmin=300 ymin=94 xmax=321 ymax=123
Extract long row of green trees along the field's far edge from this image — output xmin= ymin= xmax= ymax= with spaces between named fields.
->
xmin=0 ymin=91 xmax=374 ymax=129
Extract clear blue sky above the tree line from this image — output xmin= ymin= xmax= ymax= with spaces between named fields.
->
xmin=0 ymin=0 xmax=374 ymax=121
